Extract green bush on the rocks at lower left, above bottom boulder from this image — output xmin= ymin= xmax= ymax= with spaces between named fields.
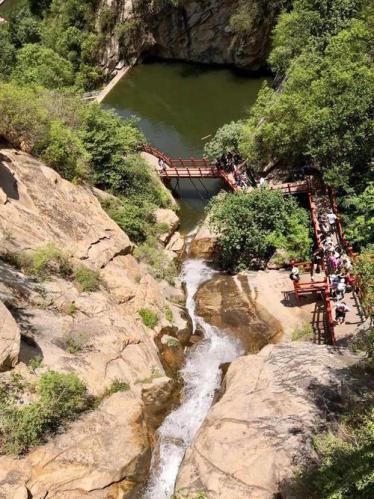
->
xmin=0 ymin=371 xmax=91 ymax=454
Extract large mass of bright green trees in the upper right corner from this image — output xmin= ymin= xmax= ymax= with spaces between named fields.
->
xmin=240 ymin=0 xmax=374 ymax=247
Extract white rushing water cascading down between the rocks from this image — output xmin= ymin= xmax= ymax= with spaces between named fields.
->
xmin=144 ymin=260 xmax=243 ymax=499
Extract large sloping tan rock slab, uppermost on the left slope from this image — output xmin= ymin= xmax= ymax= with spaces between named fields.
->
xmin=0 ymin=149 xmax=133 ymax=268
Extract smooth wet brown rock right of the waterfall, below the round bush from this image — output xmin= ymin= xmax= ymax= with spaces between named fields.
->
xmin=196 ymin=275 xmax=283 ymax=352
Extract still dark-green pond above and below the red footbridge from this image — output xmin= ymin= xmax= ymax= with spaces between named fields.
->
xmin=104 ymin=61 xmax=266 ymax=234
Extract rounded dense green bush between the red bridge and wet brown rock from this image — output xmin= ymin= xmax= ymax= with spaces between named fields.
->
xmin=208 ymin=188 xmax=311 ymax=270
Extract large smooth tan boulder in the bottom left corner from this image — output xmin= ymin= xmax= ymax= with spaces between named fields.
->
xmin=0 ymin=392 xmax=151 ymax=499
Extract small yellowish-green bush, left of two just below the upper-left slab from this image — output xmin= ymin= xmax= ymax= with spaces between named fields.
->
xmin=30 ymin=243 xmax=72 ymax=279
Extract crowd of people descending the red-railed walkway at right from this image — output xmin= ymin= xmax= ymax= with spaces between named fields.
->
xmin=290 ymin=211 xmax=354 ymax=324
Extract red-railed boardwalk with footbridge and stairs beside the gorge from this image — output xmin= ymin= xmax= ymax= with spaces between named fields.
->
xmin=144 ymin=145 xmax=363 ymax=345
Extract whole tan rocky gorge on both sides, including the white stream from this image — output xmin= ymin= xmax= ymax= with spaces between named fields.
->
xmin=0 ymin=148 xmax=366 ymax=499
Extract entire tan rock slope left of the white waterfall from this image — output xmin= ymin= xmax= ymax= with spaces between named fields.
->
xmin=0 ymin=149 xmax=187 ymax=499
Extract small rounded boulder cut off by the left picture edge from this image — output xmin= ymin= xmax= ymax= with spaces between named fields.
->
xmin=0 ymin=302 xmax=21 ymax=371
